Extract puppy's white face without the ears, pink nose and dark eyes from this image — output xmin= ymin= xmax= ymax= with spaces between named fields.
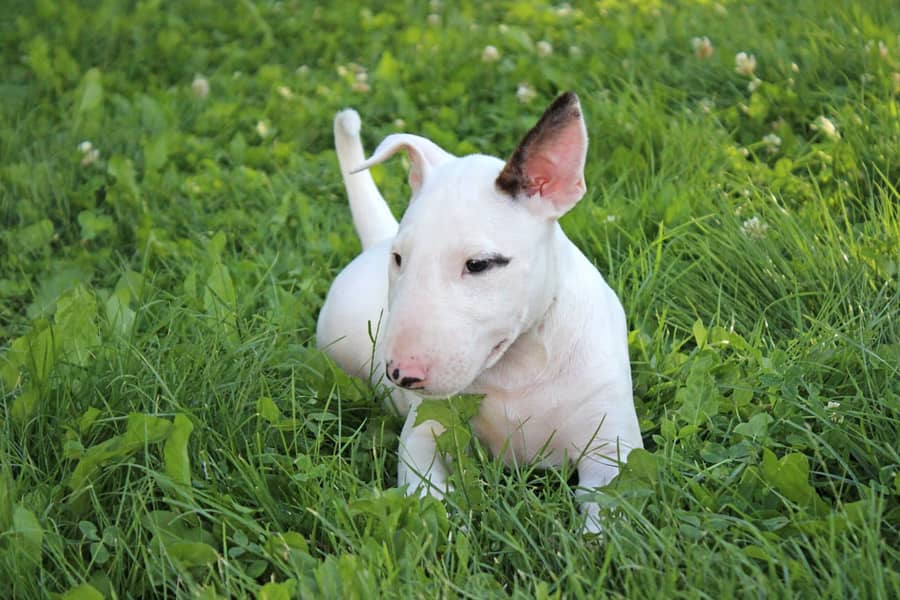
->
xmin=385 ymin=156 xmax=553 ymax=396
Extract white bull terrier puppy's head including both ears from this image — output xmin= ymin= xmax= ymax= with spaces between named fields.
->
xmin=352 ymin=93 xmax=587 ymax=396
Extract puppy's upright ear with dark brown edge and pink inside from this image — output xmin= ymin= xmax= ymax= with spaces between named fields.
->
xmin=496 ymin=92 xmax=587 ymax=218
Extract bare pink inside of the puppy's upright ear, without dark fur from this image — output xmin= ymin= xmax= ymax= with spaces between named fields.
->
xmin=523 ymin=119 xmax=587 ymax=210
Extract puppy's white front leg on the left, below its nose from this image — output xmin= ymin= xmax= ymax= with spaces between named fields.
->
xmin=397 ymin=408 xmax=448 ymax=500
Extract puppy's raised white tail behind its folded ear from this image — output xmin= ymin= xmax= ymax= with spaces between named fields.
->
xmin=334 ymin=108 xmax=397 ymax=250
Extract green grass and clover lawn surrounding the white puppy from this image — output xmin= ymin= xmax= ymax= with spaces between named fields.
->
xmin=0 ymin=0 xmax=900 ymax=598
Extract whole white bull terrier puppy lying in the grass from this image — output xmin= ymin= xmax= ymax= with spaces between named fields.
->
xmin=317 ymin=93 xmax=642 ymax=531
